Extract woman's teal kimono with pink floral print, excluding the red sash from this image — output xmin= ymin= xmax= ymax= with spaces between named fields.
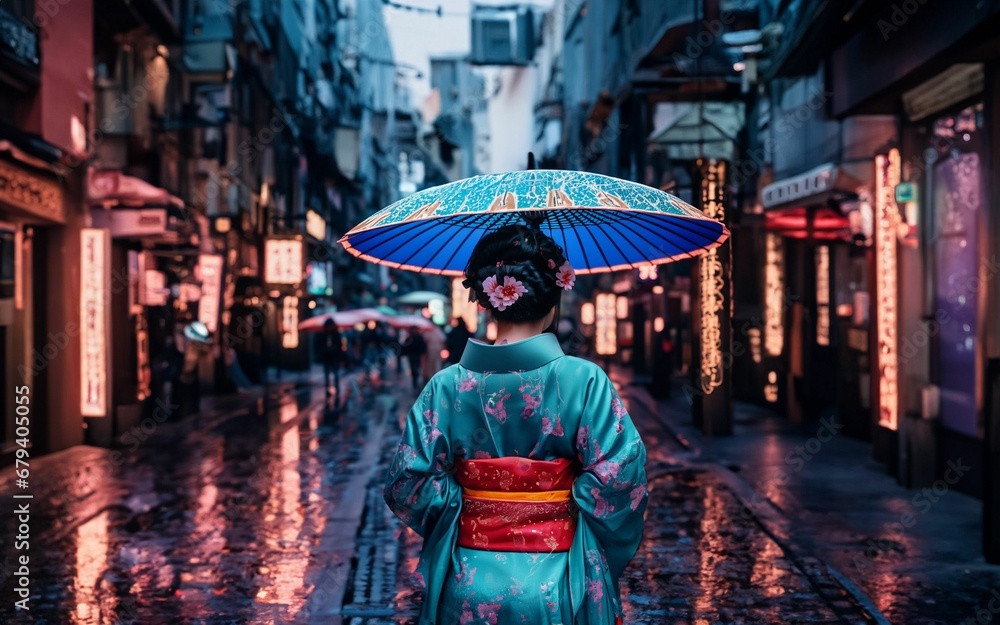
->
xmin=384 ymin=334 xmax=647 ymax=625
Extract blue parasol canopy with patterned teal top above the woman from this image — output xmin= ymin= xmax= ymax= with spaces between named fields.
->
xmin=340 ymin=169 xmax=729 ymax=276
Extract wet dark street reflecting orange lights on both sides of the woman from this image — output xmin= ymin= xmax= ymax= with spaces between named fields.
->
xmin=0 ymin=364 xmax=952 ymax=625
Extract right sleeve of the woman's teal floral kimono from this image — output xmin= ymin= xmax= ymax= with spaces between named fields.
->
xmin=573 ymin=371 xmax=648 ymax=586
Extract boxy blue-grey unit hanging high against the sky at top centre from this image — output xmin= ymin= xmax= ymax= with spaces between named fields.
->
xmin=470 ymin=6 xmax=535 ymax=65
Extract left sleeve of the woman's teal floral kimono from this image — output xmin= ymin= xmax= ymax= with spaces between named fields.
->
xmin=383 ymin=379 xmax=461 ymax=537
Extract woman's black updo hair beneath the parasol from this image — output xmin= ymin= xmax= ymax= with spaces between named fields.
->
xmin=463 ymin=224 xmax=566 ymax=323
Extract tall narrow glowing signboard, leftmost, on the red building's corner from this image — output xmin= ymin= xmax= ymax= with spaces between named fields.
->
xmin=80 ymin=228 xmax=108 ymax=417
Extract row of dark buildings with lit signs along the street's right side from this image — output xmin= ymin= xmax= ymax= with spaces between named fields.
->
xmin=536 ymin=0 xmax=1000 ymax=560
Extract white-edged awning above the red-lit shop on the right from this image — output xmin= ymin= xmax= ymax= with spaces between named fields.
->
xmin=760 ymin=161 xmax=873 ymax=210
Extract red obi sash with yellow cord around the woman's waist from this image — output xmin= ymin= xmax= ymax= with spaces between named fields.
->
xmin=455 ymin=457 xmax=578 ymax=552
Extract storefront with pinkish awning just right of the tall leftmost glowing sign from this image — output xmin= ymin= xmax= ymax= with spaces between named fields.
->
xmin=89 ymin=171 xmax=196 ymax=444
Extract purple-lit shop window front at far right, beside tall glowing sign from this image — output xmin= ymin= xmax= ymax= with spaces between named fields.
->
xmin=895 ymin=97 xmax=996 ymax=496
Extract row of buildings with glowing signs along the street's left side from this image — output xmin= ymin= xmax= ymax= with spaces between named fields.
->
xmin=0 ymin=0 xmax=426 ymax=456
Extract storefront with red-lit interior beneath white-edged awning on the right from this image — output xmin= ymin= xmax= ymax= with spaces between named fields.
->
xmin=750 ymin=163 xmax=871 ymax=428
